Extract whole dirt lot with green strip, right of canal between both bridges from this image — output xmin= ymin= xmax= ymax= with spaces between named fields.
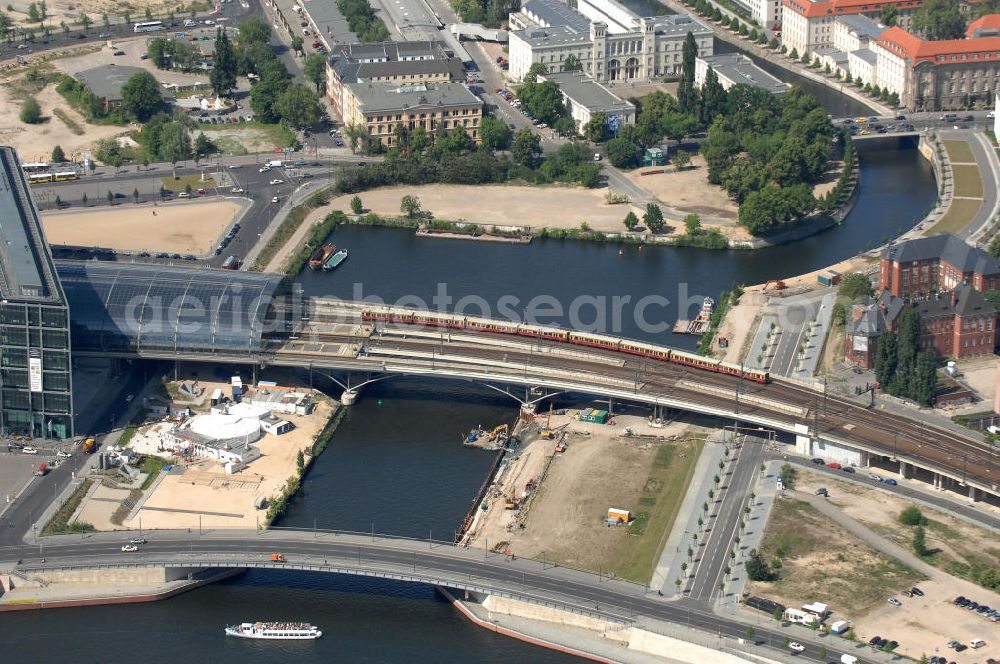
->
xmin=475 ymin=411 xmax=701 ymax=582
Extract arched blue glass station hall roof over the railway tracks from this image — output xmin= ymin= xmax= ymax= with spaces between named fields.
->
xmin=56 ymin=261 xmax=281 ymax=357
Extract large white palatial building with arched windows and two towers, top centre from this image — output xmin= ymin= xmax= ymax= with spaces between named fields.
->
xmin=509 ymin=0 xmax=714 ymax=81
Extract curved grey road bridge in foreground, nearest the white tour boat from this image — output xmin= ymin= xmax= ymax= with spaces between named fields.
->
xmin=0 ymin=529 xmax=849 ymax=661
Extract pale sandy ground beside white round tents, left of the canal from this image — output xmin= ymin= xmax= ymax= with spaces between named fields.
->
xmin=125 ymin=400 xmax=332 ymax=529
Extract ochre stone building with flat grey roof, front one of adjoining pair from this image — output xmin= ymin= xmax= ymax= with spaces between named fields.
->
xmin=343 ymin=83 xmax=483 ymax=147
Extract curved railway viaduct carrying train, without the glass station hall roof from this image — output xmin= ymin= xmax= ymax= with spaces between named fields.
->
xmin=66 ymin=290 xmax=1000 ymax=501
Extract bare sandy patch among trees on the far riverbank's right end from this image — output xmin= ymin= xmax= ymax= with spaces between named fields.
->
xmin=627 ymin=155 xmax=739 ymax=224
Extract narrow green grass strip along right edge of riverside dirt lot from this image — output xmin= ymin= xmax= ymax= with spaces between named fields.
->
xmin=611 ymin=440 xmax=704 ymax=583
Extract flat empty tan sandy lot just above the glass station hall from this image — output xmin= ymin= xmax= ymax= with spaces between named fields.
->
xmin=42 ymin=200 xmax=240 ymax=255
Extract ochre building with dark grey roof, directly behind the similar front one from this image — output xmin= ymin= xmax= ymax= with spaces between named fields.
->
xmin=326 ymin=41 xmax=465 ymax=117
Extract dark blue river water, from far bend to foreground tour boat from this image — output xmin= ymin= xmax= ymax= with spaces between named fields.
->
xmin=0 ymin=94 xmax=935 ymax=664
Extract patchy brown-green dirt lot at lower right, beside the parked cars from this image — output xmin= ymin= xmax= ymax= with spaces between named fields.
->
xmin=750 ymin=498 xmax=923 ymax=628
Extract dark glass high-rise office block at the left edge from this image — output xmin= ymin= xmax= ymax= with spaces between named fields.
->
xmin=0 ymin=147 xmax=75 ymax=438
